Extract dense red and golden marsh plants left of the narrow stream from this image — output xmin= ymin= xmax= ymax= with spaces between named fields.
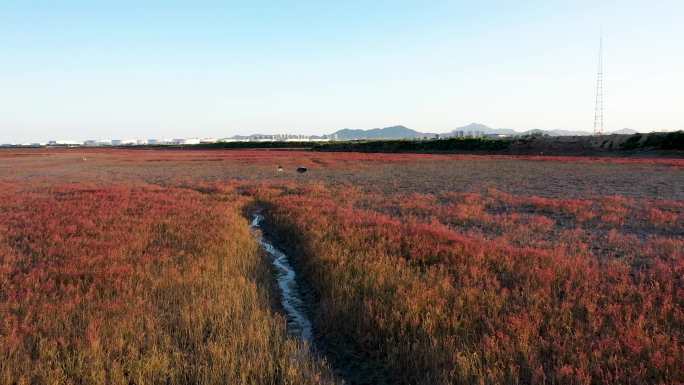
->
xmin=0 ymin=184 xmax=333 ymax=384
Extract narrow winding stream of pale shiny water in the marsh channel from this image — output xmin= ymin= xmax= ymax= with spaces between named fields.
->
xmin=251 ymin=214 xmax=312 ymax=343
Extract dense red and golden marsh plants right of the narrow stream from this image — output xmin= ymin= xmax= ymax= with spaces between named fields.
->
xmin=252 ymin=185 xmax=684 ymax=384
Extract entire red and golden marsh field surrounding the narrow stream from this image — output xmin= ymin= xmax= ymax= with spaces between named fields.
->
xmin=0 ymin=149 xmax=684 ymax=384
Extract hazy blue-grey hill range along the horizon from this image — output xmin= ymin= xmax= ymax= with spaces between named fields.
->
xmin=325 ymin=123 xmax=637 ymax=140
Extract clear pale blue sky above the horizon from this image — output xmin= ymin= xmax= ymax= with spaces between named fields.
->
xmin=0 ymin=0 xmax=684 ymax=143
